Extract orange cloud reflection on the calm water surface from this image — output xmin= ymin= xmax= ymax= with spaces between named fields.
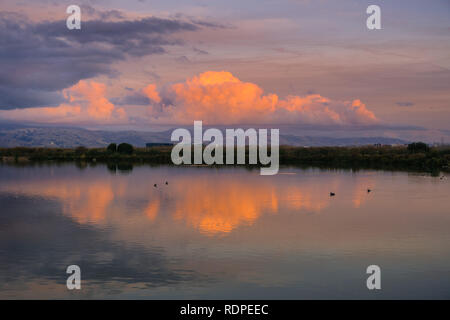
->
xmin=0 ymin=165 xmax=375 ymax=235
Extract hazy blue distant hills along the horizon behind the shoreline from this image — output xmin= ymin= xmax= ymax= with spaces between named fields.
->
xmin=0 ymin=124 xmax=407 ymax=148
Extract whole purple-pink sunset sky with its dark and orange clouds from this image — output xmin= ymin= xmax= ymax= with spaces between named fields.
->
xmin=0 ymin=0 xmax=450 ymax=142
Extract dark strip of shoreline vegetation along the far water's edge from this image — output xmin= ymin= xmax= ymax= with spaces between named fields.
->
xmin=0 ymin=142 xmax=450 ymax=172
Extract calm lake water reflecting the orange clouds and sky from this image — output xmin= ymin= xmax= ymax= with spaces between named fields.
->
xmin=0 ymin=164 xmax=450 ymax=299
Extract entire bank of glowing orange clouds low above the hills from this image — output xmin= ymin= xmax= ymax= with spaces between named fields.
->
xmin=0 ymin=71 xmax=379 ymax=127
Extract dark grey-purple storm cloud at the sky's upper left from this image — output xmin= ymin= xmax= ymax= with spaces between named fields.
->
xmin=0 ymin=13 xmax=206 ymax=109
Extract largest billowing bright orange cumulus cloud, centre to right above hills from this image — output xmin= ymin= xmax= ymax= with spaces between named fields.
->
xmin=144 ymin=71 xmax=378 ymax=125
